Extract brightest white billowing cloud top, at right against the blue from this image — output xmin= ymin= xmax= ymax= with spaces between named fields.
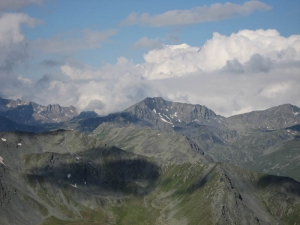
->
xmin=142 ymin=30 xmax=300 ymax=79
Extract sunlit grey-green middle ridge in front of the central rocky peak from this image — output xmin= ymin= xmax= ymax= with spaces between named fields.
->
xmin=90 ymin=123 xmax=211 ymax=163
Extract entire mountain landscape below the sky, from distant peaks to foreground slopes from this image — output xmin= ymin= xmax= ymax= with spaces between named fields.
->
xmin=0 ymin=97 xmax=300 ymax=224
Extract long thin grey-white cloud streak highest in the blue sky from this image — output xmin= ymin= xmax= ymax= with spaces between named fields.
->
xmin=121 ymin=1 xmax=271 ymax=27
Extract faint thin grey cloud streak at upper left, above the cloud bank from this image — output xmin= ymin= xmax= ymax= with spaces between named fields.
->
xmin=32 ymin=29 xmax=118 ymax=53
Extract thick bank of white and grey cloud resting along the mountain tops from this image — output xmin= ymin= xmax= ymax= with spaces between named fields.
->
xmin=0 ymin=27 xmax=300 ymax=116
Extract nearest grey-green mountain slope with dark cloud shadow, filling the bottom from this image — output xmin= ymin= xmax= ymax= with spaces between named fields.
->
xmin=0 ymin=130 xmax=300 ymax=224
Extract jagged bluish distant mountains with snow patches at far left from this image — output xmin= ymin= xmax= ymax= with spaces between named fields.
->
xmin=0 ymin=98 xmax=78 ymax=125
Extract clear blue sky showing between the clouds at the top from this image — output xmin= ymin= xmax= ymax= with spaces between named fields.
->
xmin=23 ymin=0 xmax=300 ymax=66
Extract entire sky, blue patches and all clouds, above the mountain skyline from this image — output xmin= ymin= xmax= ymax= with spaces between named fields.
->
xmin=0 ymin=0 xmax=300 ymax=116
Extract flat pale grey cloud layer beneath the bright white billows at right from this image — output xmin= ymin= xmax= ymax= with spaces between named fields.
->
xmin=152 ymin=68 xmax=300 ymax=116
